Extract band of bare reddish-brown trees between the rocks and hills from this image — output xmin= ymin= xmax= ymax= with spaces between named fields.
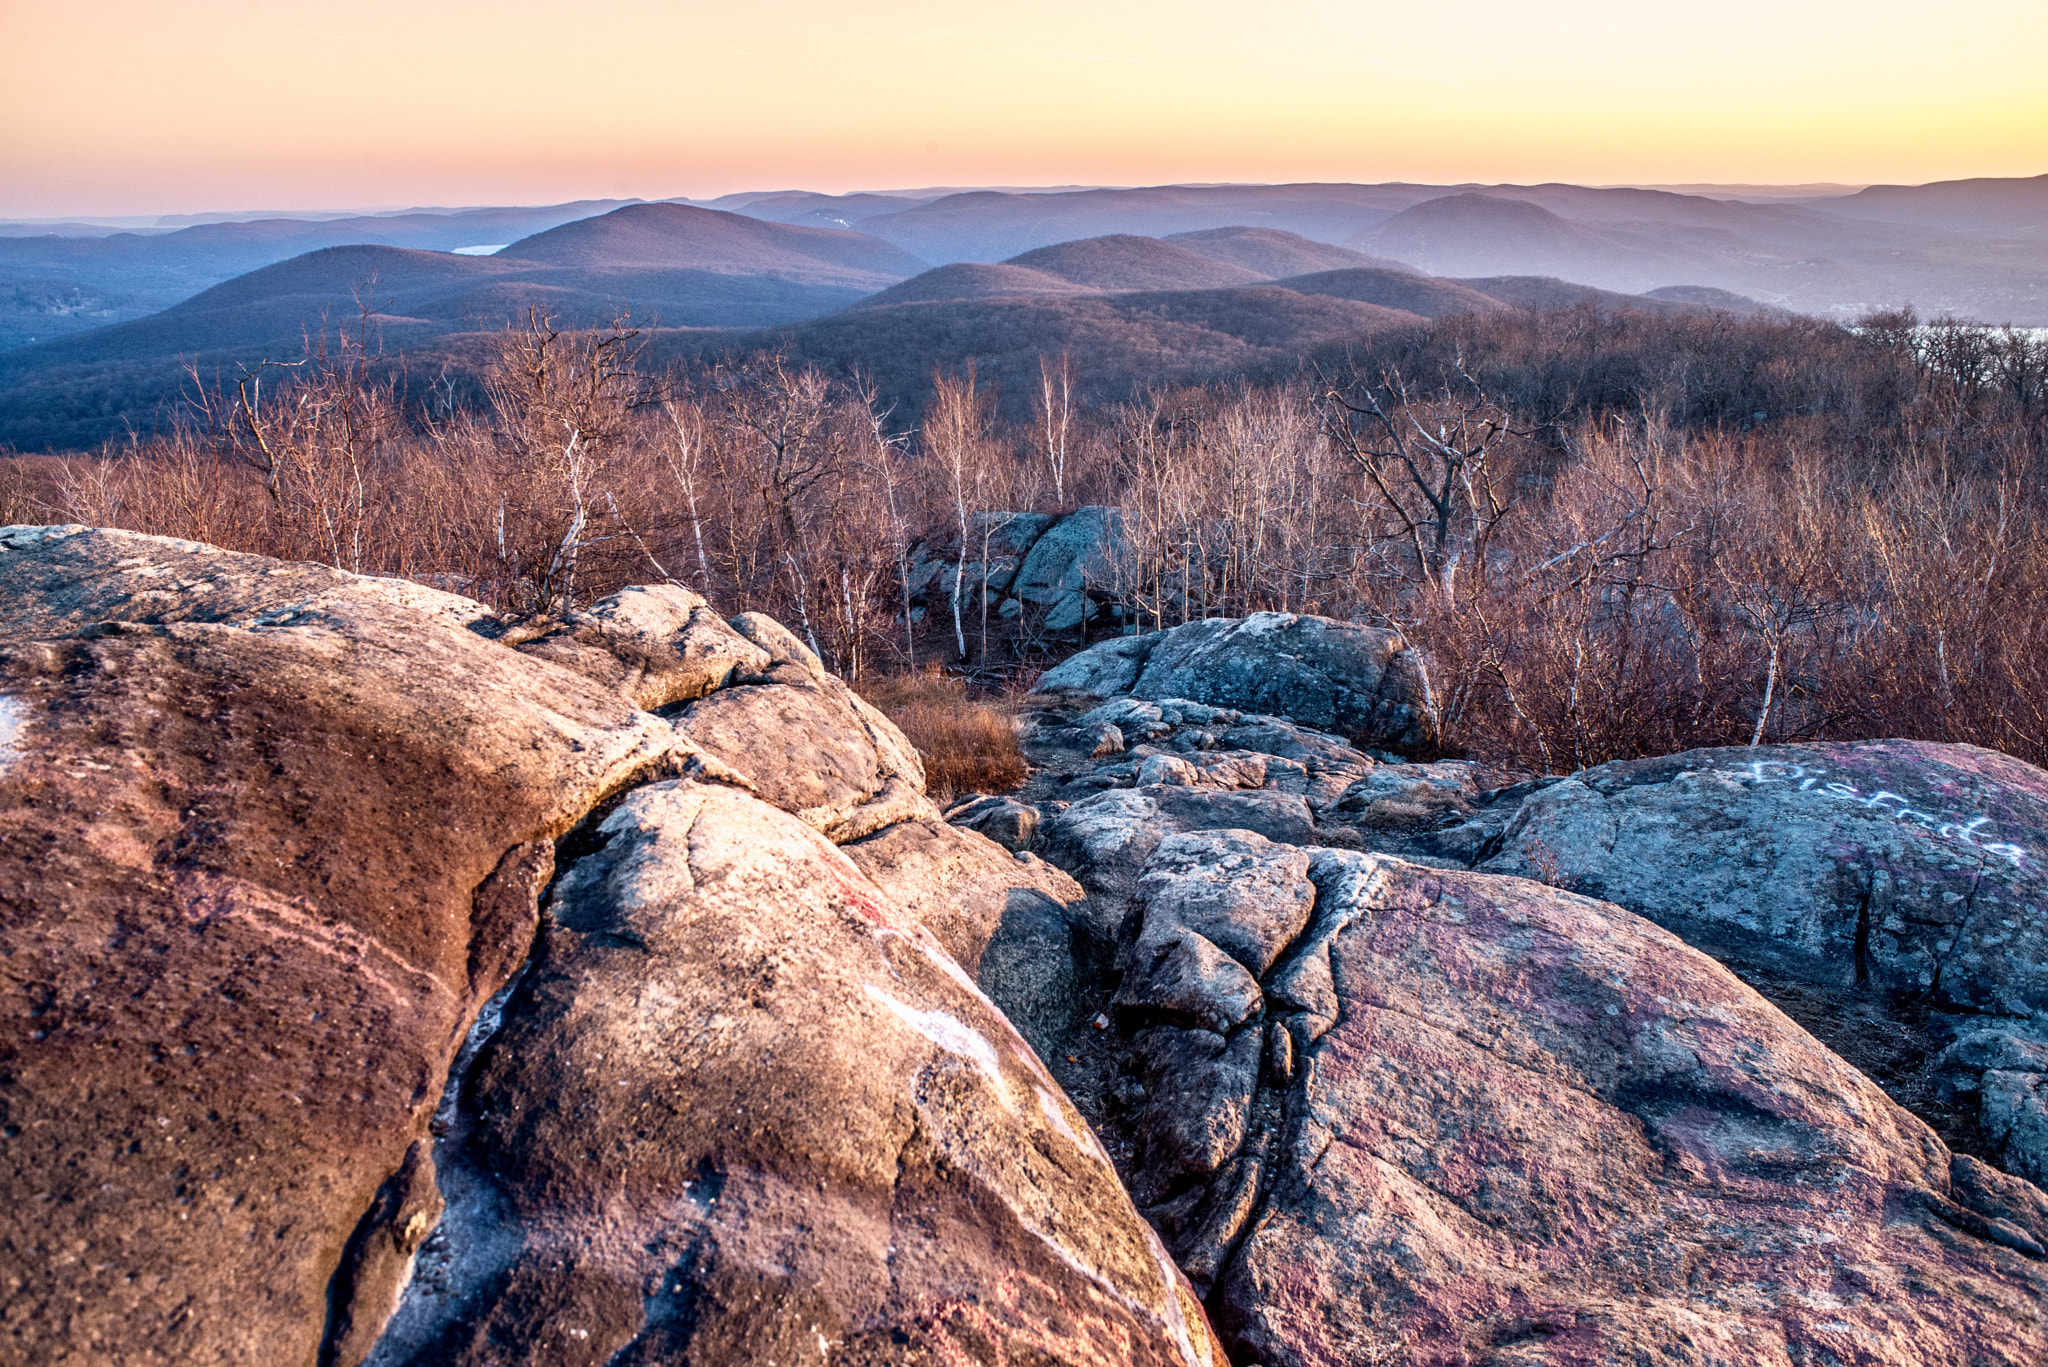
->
xmin=0 ymin=307 xmax=2048 ymax=773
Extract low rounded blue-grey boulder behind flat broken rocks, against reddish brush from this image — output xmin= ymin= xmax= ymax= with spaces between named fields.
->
xmin=1038 ymin=613 xmax=1436 ymax=752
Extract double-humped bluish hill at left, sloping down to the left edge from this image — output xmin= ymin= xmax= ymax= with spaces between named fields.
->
xmin=0 ymin=205 xmax=937 ymax=449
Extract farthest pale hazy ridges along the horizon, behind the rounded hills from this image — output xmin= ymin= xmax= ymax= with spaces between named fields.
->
xmin=0 ymin=176 xmax=2048 ymax=353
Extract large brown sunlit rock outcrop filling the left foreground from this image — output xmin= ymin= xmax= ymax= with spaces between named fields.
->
xmin=0 ymin=527 xmax=1212 ymax=1367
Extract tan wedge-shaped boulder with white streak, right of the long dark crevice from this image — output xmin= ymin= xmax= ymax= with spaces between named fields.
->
xmin=373 ymin=781 xmax=1221 ymax=1367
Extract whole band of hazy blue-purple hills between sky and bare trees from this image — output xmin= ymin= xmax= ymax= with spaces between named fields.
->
xmin=0 ymin=176 xmax=2048 ymax=449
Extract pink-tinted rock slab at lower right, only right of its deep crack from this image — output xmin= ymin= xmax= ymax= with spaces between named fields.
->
xmin=1214 ymin=855 xmax=2048 ymax=1367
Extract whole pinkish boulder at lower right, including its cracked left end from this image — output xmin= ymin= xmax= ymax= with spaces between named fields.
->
xmin=1055 ymin=832 xmax=2048 ymax=1367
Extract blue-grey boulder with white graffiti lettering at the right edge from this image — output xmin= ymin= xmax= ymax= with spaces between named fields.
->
xmin=1485 ymin=740 xmax=2048 ymax=1174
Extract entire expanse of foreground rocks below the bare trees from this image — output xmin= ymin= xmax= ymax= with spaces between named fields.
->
xmin=0 ymin=549 xmax=2048 ymax=1367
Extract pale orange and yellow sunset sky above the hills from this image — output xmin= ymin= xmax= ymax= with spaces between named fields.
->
xmin=0 ymin=0 xmax=2048 ymax=217
